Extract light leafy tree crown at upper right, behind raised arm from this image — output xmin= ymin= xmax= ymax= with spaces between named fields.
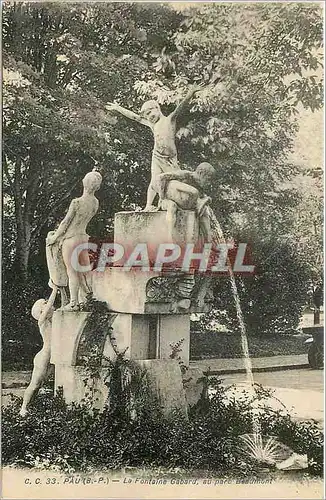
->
xmin=136 ymin=4 xmax=322 ymax=229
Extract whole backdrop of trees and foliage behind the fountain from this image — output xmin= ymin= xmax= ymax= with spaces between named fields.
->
xmin=3 ymin=3 xmax=323 ymax=364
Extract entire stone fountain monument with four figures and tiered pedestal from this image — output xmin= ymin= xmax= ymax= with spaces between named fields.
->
xmin=21 ymin=87 xmax=219 ymax=415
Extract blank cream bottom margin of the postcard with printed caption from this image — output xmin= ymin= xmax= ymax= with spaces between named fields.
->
xmin=2 ymin=467 xmax=323 ymax=500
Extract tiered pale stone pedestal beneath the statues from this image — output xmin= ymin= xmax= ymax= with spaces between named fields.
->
xmin=51 ymin=211 xmax=210 ymax=413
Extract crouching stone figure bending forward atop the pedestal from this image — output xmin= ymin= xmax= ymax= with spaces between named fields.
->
xmin=154 ymin=162 xmax=216 ymax=242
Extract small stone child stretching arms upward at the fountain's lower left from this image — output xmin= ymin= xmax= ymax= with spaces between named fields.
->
xmin=19 ymin=285 xmax=58 ymax=417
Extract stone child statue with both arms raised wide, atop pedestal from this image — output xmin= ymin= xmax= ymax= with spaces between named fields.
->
xmin=106 ymin=85 xmax=203 ymax=211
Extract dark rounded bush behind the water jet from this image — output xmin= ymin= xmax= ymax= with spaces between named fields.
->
xmin=201 ymin=234 xmax=311 ymax=335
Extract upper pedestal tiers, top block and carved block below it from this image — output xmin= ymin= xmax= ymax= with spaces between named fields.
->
xmin=92 ymin=210 xmax=211 ymax=314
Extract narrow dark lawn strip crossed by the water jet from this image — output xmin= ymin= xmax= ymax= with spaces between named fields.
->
xmin=190 ymin=331 xmax=308 ymax=360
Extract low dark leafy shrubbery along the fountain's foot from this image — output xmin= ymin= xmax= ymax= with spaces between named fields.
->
xmin=2 ymin=378 xmax=323 ymax=474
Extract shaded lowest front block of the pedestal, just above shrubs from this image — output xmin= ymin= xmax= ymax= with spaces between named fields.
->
xmin=139 ymin=359 xmax=187 ymax=416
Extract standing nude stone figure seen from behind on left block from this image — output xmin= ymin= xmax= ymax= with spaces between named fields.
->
xmin=46 ymin=171 xmax=102 ymax=311
